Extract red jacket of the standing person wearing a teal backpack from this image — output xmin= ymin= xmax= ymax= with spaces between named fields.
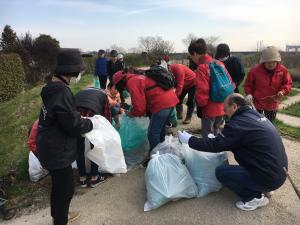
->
xmin=195 ymin=55 xmax=231 ymax=118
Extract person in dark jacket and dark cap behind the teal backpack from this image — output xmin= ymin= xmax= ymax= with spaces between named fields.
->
xmin=215 ymin=44 xmax=245 ymax=93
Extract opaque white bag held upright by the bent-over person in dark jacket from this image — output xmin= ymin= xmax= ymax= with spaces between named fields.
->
xmin=85 ymin=115 xmax=127 ymax=173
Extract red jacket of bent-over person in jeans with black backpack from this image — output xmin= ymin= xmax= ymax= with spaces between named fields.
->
xmin=126 ymin=74 xmax=179 ymax=116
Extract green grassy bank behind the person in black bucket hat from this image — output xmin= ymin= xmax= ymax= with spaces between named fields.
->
xmin=0 ymin=75 xmax=92 ymax=179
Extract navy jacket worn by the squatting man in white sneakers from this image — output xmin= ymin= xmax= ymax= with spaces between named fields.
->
xmin=189 ymin=106 xmax=288 ymax=190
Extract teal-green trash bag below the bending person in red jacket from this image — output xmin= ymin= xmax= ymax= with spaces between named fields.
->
xmin=118 ymin=116 xmax=149 ymax=152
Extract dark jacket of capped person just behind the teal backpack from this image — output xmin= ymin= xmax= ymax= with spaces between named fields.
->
xmin=223 ymin=56 xmax=245 ymax=86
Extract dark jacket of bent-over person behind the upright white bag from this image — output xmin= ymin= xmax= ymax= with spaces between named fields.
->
xmin=75 ymin=88 xmax=108 ymax=115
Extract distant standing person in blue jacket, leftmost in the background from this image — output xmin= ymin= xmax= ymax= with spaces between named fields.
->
xmin=94 ymin=49 xmax=108 ymax=90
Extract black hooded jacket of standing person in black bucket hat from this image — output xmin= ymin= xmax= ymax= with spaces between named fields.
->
xmin=37 ymin=81 xmax=93 ymax=170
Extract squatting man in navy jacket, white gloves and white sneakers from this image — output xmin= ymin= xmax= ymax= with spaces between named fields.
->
xmin=178 ymin=93 xmax=288 ymax=211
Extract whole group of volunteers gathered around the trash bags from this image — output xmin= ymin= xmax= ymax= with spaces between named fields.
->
xmin=33 ymin=39 xmax=292 ymax=225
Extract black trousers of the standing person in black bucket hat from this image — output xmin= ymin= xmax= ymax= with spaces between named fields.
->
xmin=50 ymin=165 xmax=74 ymax=225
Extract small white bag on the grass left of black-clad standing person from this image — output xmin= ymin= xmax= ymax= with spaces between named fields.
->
xmin=28 ymin=151 xmax=48 ymax=182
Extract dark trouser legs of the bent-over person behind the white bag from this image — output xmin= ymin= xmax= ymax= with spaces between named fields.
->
xmin=76 ymin=136 xmax=98 ymax=177
